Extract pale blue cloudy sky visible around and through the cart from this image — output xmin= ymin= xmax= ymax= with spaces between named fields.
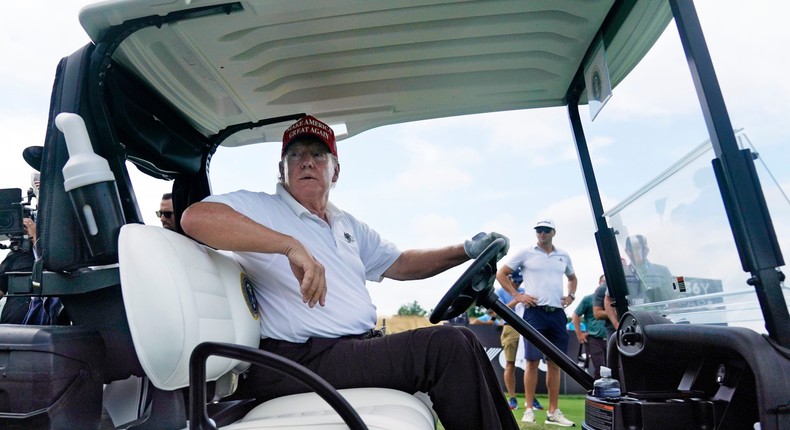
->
xmin=0 ymin=0 xmax=790 ymax=315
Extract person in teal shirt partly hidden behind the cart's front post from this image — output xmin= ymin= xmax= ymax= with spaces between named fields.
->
xmin=572 ymin=275 xmax=609 ymax=379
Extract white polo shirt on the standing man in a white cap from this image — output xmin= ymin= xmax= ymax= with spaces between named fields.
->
xmin=505 ymin=245 xmax=574 ymax=308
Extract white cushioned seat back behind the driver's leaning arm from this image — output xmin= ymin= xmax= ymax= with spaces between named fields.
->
xmin=119 ymin=224 xmax=260 ymax=391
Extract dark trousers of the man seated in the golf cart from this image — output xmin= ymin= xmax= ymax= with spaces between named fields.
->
xmin=237 ymin=326 xmax=518 ymax=430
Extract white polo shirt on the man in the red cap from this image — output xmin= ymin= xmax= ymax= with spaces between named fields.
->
xmin=203 ymin=184 xmax=401 ymax=343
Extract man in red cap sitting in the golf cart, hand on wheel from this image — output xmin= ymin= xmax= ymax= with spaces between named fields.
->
xmin=181 ymin=116 xmax=518 ymax=429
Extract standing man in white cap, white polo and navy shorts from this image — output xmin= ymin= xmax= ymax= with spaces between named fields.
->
xmin=497 ymin=219 xmax=577 ymax=427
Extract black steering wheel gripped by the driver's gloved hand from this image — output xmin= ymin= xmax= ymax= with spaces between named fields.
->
xmin=428 ymin=238 xmax=505 ymax=324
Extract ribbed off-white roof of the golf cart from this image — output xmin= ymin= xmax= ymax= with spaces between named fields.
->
xmin=80 ymin=0 xmax=671 ymax=146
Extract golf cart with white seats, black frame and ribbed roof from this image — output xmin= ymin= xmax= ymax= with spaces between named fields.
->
xmin=0 ymin=0 xmax=790 ymax=429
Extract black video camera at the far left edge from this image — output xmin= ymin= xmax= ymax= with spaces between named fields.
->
xmin=0 ymin=188 xmax=36 ymax=250
